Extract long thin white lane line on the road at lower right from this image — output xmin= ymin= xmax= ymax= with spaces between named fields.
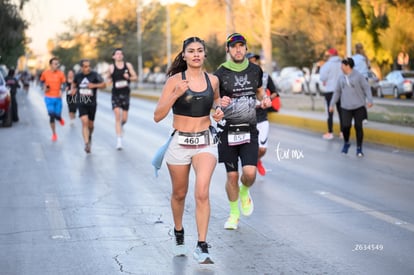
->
xmin=316 ymin=191 xmax=414 ymax=235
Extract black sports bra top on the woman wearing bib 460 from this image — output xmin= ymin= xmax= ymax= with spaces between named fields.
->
xmin=173 ymin=72 xmax=214 ymax=117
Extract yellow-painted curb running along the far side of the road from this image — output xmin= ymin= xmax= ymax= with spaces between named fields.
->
xmin=132 ymin=88 xmax=414 ymax=151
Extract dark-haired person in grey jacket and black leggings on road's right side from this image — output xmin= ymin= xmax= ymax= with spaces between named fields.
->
xmin=329 ymin=57 xmax=373 ymax=157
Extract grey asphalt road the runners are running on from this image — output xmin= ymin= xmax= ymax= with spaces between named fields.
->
xmin=0 ymin=85 xmax=414 ymax=275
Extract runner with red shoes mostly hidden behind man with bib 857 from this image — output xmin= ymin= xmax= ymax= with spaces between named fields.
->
xmin=246 ymin=53 xmax=279 ymax=176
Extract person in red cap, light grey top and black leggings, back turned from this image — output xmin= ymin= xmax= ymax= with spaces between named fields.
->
xmin=319 ymin=48 xmax=342 ymax=140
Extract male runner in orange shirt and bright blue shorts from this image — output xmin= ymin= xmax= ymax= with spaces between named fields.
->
xmin=40 ymin=57 xmax=66 ymax=141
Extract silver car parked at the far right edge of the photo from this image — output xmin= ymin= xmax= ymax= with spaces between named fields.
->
xmin=378 ymin=71 xmax=414 ymax=98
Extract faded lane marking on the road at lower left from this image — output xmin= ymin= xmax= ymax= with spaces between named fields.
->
xmin=45 ymin=194 xmax=70 ymax=240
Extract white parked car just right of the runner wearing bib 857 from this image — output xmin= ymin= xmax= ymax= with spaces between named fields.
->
xmin=273 ymin=67 xmax=305 ymax=93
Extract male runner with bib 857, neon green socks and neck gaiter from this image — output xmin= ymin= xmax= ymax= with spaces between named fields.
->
xmin=214 ymin=33 xmax=272 ymax=229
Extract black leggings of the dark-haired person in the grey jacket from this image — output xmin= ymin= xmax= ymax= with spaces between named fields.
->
xmin=342 ymin=106 xmax=367 ymax=147
